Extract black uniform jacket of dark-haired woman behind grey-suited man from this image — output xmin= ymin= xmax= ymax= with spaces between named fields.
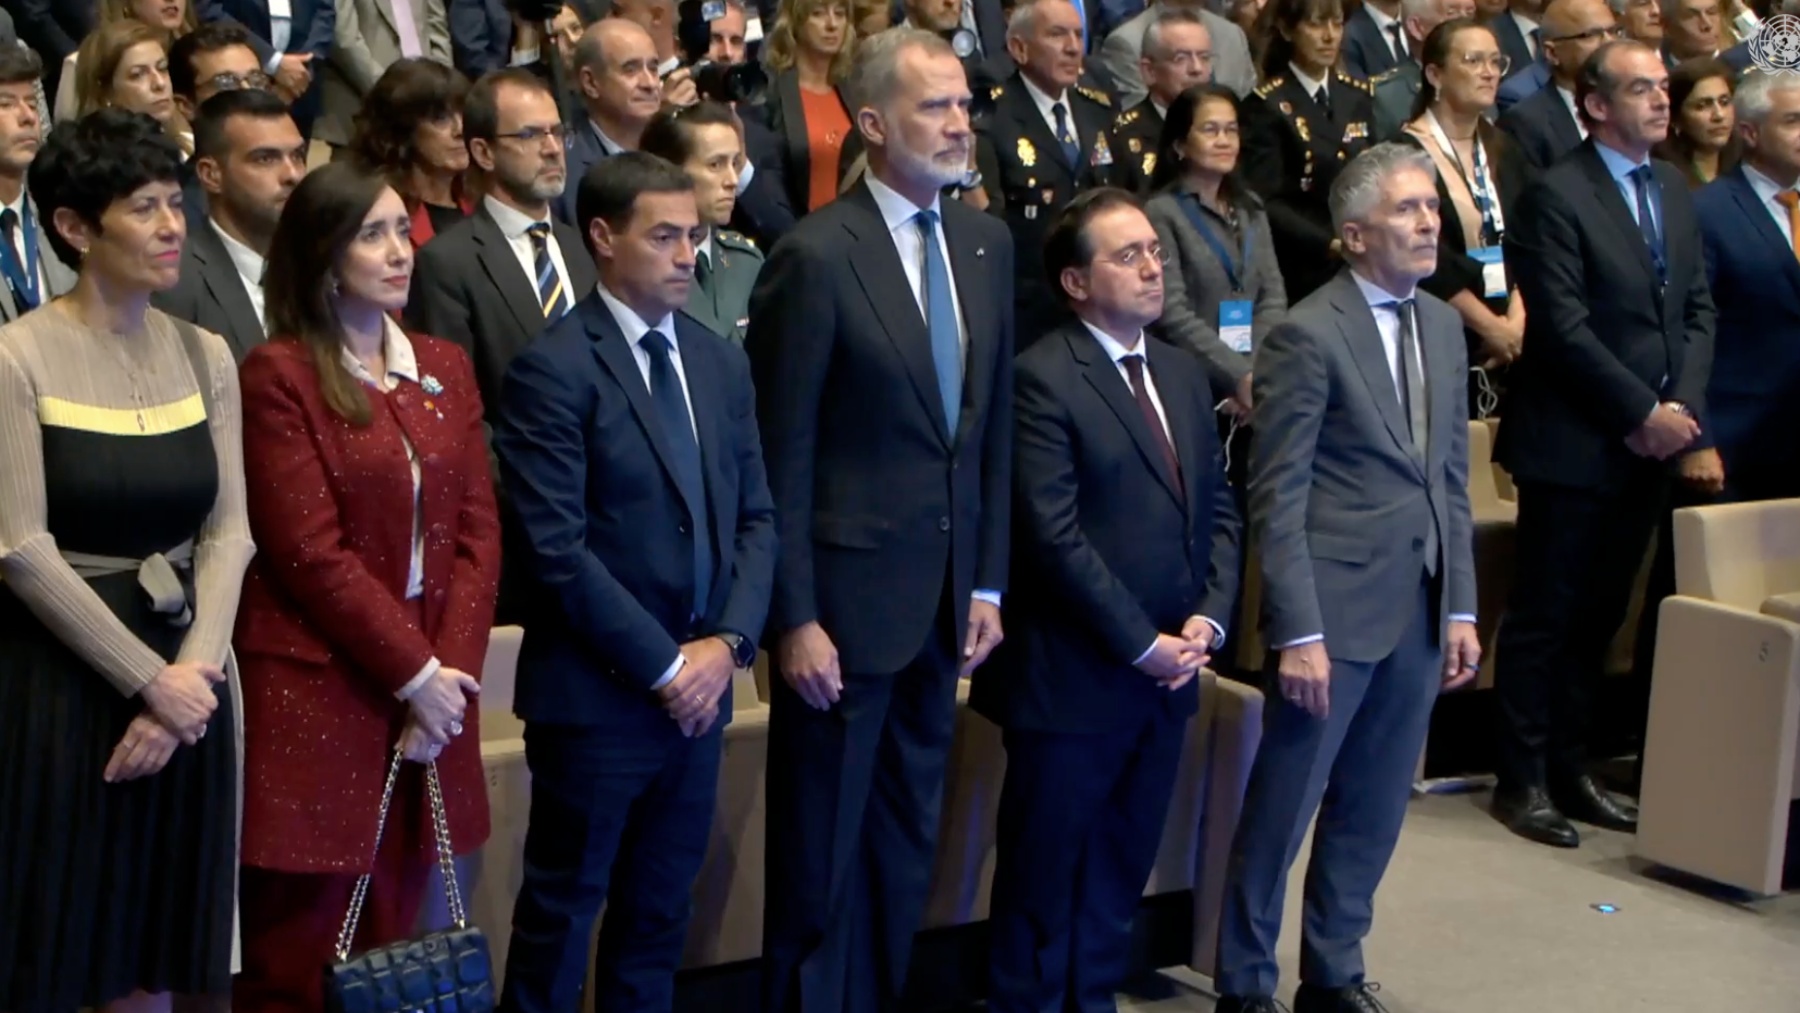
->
xmin=1238 ymin=72 xmax=1373 ymax=306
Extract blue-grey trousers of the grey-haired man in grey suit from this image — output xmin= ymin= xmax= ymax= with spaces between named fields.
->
xmin=1213 ymin=581 xmax=1444 ymax=997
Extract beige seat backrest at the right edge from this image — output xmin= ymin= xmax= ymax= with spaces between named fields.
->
xmin=1674 ymin=500 xmax=1800 ymax=612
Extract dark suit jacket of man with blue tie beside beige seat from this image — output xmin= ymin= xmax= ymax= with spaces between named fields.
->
xmin=1496 ymin=140 xmax=1714 ymax=489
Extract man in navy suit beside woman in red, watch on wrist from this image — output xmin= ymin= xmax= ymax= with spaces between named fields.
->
xmin=493 ymin=153 xmax=776 ymax=1013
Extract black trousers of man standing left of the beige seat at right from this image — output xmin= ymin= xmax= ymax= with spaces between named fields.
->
xmin=1494 ymin=466 xmax=1669 ymax=790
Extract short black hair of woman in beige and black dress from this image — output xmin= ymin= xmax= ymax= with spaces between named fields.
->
xmin=27 ymin=108 xmax=182 ymax=270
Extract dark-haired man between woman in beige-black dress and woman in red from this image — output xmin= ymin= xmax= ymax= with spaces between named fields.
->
xmin=151 ymin=88 xmax=306 ymax=362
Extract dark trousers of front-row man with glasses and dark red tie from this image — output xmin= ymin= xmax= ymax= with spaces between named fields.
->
xmin=988 ymin=705 xmax=1188 ymax=1013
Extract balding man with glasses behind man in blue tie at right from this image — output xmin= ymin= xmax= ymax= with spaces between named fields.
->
xmin=1499 ymin=0 xmax=1620 ymax=169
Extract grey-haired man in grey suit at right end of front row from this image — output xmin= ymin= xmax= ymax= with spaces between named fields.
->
xmin=1213 ymin=144 xmax=1481 ymax=1013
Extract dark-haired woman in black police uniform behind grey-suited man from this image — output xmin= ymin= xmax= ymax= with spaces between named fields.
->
xmin=1242 ymin=0 xmax=1373 ymax=302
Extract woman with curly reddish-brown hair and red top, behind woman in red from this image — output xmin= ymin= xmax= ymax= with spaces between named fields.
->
xmin=349 ymin=58 xmax=475 ymax=248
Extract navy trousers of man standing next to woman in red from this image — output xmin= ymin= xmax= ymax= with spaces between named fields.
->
xmin=500 ymin=714 xmax=724 ymax=1013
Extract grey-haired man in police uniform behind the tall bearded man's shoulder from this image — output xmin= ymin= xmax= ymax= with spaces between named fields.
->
xmin=976 ymin=0 xmax=1116 ymax=344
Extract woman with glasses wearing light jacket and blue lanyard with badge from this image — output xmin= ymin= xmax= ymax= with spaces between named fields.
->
xmin=1397 ymin=18 xmax=1528 ymax=419
